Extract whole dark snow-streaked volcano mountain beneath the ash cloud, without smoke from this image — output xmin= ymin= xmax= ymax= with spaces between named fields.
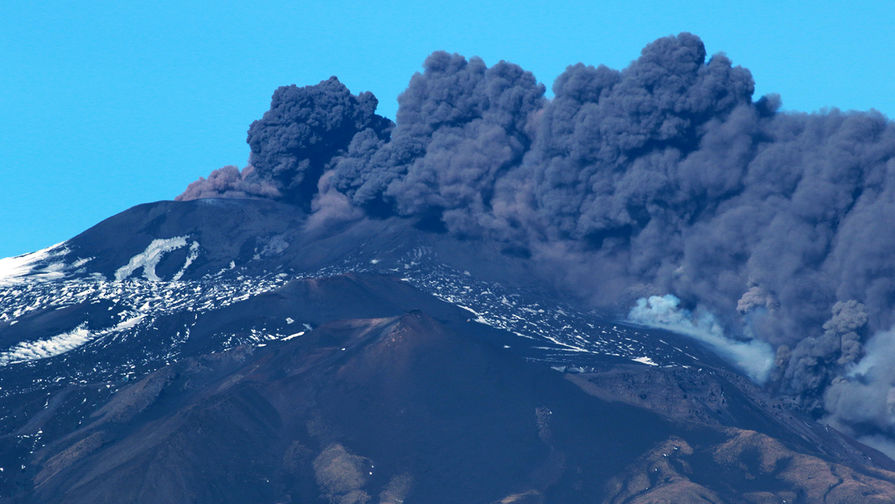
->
xmin=0 ymin=199 xmax=895 ymax=503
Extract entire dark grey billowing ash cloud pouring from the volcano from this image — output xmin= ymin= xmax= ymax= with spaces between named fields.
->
xmin=181 ymin=33 xmax=895 ymax=444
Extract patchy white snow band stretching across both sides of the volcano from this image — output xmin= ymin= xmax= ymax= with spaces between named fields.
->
xmin=0 ymin=236 xmax=712 ymax=386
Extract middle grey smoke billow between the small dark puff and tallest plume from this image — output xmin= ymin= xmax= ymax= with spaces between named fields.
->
xmin=333 ymin=48 xmax=545 ymax=230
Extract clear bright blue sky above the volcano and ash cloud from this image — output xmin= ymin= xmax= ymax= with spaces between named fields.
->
xmin=0 ymin=0 xmax=895 ymax=257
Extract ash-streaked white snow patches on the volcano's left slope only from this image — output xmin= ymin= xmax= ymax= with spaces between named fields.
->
xmin=0 ymin=236 xmax=302 ymax=381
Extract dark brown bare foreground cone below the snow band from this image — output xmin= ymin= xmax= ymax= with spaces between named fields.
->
xmin=26 ymin=312 xmax=671 ymax=503
